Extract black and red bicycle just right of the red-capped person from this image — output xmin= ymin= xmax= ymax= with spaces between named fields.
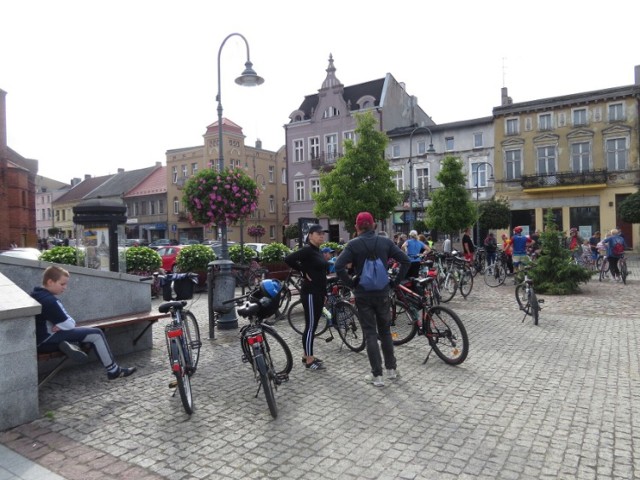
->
xmin=390 ymin=277 xmax=469 ymax=365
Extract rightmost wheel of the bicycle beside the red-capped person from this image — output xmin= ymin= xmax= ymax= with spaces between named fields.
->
xmin=423 ymin=305 xmax=469 ymax=365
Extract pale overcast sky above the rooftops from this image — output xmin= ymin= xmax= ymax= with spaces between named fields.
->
xmin=0 ymin=0 xmax=640 ymax=182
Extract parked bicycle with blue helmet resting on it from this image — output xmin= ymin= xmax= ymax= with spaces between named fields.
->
xmin=216 ymin=280 xmax=293 ymax=418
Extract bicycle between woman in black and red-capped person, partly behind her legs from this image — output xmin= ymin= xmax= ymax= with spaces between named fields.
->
xmin=287 ymin=278 xmax=365 ymax=352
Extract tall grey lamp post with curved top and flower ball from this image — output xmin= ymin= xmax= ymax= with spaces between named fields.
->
xmin=209 ymin=33 xmax=264 ymax=338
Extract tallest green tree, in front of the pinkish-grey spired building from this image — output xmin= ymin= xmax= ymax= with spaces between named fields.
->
xmin=313 ymin=113 xmax=400 ymax=233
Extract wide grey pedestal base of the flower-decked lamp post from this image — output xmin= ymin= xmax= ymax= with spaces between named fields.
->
xmin=208 ymin=260 xmax=238 ymax=332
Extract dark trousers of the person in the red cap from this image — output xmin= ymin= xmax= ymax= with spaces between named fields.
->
xmin=356 ymin=295 xmax=396 ymax=377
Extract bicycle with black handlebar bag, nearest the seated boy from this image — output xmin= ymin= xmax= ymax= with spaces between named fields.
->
xmin=140 ymin=273 xmax=202 ymax=415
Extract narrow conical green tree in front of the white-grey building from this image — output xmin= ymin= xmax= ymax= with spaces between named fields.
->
xmin=427 ymin=156 xmax=477 ymax=234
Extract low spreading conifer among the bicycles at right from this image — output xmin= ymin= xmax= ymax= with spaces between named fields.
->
xmin=529 ymin=209 xmax=592 ymax=295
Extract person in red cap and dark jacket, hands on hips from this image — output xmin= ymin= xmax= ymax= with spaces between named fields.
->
xmin=336 ymin=212 xmax=410 ymax=387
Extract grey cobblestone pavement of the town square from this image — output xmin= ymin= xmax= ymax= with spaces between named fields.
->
xmin=0 ymin=259 xmax=640 ymax=480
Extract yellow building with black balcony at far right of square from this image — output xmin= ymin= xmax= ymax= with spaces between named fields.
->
xmin=493 ymin=71 xmax=640 ymax=251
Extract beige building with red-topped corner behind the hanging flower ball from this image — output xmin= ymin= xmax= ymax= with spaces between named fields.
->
xmin=166 ymin=118 xmax=287 ymax=243
